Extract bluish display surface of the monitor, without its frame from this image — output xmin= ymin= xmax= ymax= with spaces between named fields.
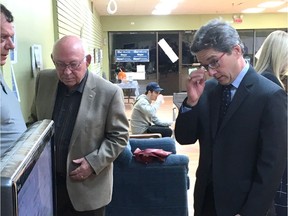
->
xmin=16 ymin=142 xmax=53 ymax=216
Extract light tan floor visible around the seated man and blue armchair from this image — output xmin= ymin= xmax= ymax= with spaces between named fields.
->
xmin=125 ymin=96 xmax=199 ymax=216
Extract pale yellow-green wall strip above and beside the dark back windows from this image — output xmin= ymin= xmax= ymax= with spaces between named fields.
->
xmin=100 ymin=13 xmax=288 ymax=76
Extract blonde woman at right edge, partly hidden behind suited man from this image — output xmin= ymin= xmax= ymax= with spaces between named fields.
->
xmin=255 ymin=30 xmax=288 ymax=216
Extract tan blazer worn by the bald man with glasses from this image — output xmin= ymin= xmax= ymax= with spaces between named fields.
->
xmin=29 ymin=70 xmax=129 ymax=211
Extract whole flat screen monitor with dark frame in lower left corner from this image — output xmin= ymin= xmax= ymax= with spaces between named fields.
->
xmin=1 ymin=120 xmax=54 ymax=216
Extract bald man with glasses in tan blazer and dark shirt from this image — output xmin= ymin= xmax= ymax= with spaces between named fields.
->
xmin=29 ymin=35 xmax=129 ymax=216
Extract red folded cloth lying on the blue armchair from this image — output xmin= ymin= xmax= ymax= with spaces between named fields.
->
xmin=133 ymin=148 xmax=172 ymax=164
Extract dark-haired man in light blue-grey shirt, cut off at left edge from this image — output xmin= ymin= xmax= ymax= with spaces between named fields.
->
xmin=0 ymin=4 xmax=26 ymax=155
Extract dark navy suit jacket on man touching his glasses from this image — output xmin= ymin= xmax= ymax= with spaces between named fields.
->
xmin=175 ymin=67 xmax=287 ymax=216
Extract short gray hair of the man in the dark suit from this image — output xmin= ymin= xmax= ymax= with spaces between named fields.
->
xmin=191 ymin=19 xmax=244 ymax=54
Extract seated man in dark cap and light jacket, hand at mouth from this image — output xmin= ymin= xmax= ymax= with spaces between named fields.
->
xmin=131 ymin=82 xmax=172 ymax=137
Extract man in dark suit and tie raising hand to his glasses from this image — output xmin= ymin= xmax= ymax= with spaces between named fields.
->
xmin=175 ymin=19 xmax=287 ymax=216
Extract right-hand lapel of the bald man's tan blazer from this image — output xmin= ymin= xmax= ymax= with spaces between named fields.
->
xmin=70 ymin=72 xmax=96 ymax=145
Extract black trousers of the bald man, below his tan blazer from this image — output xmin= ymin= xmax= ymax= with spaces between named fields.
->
xmin=56 ymin=175 xmax=105 ymax=216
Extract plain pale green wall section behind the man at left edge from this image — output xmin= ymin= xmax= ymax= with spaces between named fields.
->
xmin=1 ymin=0 xmax=54 ymax=120
